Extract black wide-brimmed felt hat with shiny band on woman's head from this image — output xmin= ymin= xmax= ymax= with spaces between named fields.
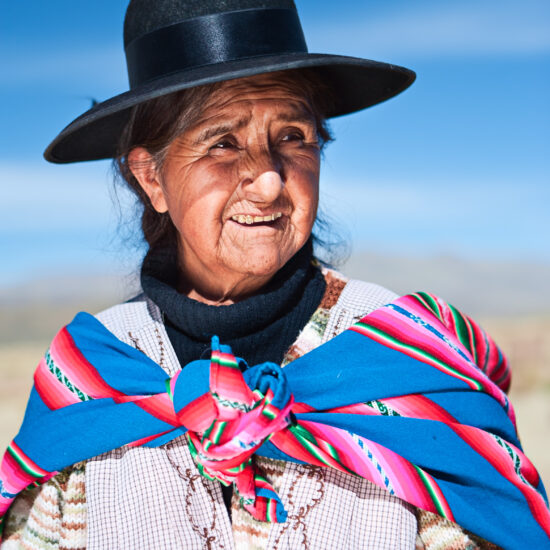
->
xmin=44 ymin=0 xmax=415 ymax=163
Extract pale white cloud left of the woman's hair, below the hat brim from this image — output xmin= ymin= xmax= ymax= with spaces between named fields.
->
xmin=0 ymin=162 xmax=139 ymax=287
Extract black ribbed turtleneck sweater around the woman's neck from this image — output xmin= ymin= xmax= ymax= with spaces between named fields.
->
xmin=141 ymin=241 xmax=326 ymax=518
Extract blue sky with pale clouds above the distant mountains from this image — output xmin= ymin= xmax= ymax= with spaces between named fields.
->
xmin=0 ymin=0 xmax=550 ymax=285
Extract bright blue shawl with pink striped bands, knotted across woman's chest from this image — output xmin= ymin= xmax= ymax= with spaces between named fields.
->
xmin=0 ymin=293 xmax=550 ymax=549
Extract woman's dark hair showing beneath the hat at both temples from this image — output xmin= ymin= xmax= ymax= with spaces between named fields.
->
xmin=114 ymin=69 xmax=332 ymax=256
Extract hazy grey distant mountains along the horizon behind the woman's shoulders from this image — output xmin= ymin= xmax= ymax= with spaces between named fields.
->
xmin=0 ymin=253 xmax=550 ymax=343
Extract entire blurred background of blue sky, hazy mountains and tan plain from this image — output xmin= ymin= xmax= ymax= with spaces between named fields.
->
xmin=0 ymin=0 xmax=550 ymax=492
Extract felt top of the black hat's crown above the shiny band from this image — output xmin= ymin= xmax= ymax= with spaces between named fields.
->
xmin=124 ymin=0 xmax=296 ymax=47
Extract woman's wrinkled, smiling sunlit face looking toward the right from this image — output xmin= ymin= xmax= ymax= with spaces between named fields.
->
xmin=133 ymin=75 xmax=320 ymax=303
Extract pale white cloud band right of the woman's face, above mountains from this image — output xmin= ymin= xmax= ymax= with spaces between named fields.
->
xmin=321 ymin=177 xmax=550 ymax=261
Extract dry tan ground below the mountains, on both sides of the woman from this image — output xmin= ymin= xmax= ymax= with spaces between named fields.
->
xmin=0 ymin=317 xmax=550 ymax=488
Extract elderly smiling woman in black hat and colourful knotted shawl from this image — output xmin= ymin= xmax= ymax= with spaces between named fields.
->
xmin=0 ymin=0 xmax=549 ymax=549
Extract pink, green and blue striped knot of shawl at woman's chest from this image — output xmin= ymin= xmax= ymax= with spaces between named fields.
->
xmin=185 ymin=337 xmax=294 ymax=522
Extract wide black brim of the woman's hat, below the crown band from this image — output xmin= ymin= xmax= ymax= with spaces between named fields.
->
xmin=44 ymin=53 xmax=415 ymax=164
